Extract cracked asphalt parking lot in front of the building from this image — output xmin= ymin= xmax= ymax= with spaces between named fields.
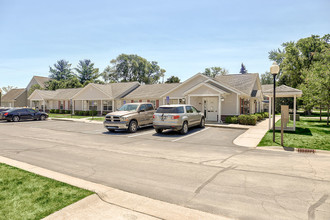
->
xmin=0 ymin=121 xmax=330 ymax=219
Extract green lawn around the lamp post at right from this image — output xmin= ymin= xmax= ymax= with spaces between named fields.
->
xmin=258 ymin=117 xmax=330 ymax=150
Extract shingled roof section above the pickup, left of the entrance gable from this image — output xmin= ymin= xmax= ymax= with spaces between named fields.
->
xmin=124 ymin=83 xmax=180 ymax=99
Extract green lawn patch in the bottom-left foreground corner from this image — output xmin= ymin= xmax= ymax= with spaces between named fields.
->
xmin=0 ymin=163 xmax=93 ymax=220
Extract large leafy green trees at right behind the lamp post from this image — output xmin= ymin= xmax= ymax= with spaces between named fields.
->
xmin=261 ymin=34 xmax=330 ymax=125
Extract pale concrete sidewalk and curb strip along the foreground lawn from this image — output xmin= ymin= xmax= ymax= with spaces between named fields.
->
xmin=0 ymin=156 xmax=229 ymax=220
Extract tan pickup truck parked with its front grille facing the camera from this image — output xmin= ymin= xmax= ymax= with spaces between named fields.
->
xmin=103 ymin=102 xmax=155 ymax=133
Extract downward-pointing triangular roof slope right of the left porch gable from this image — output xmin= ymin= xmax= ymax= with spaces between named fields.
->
xmin=93 ymin=82 xmax=140 ymax=99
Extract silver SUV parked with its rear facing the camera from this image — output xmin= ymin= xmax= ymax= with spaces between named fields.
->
xmin=153 ymin=105 xmax=205 ymax=134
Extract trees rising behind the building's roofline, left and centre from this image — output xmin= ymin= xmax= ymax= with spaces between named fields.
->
xmin=28 ymin=54 xmax=232 ymax=95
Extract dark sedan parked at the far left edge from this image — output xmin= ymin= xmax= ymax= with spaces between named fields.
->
xmin=1 ymin=108 xmax=48 ymax=122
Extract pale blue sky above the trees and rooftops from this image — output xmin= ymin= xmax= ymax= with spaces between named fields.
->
xmin=0 ymin=0 xmax=330 ymax=88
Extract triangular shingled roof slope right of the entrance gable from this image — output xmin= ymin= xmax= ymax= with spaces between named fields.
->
xmin=215 ymin=73 xmax=259 ymax=95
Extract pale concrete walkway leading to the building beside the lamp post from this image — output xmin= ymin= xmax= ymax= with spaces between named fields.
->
xmin=233 ymin=115 xmax=281 ymax=147
